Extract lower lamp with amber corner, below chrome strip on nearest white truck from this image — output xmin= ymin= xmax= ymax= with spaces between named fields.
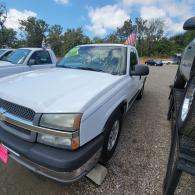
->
xmin=37 ymin=132 xmax=80 ymax=150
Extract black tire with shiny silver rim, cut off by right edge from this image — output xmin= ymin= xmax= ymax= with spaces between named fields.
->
xmin=177 ymin=74 xmax=195 ymax=138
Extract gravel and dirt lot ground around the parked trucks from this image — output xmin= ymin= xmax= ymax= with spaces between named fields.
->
xmin=0 ymin=65 xmax=193 ymax=195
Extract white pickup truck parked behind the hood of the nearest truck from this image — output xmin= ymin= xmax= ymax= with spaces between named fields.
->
xmin=0 ymin=48 xmax=57 ymax=77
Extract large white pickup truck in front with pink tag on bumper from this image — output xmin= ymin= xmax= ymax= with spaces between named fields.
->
xmin=0 ymin=44 xmax=149 ymax=182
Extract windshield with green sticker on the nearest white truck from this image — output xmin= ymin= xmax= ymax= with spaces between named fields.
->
xmin=57 ymin=46 xmax=126 ymax=75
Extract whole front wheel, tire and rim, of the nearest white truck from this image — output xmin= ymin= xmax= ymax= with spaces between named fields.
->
xmin=100 ymin=111 xmax=122 ymax=163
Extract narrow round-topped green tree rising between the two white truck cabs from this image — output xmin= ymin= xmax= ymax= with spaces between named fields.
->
xmin=47 ymin=24 xmax=64 ymax=56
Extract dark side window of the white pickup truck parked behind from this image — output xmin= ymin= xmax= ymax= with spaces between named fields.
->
xmin=28 ymin=50 xmax=52 ymax=65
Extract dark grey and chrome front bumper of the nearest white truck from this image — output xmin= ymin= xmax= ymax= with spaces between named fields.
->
xmin=0 ymin=129 xmax=103 ymax=183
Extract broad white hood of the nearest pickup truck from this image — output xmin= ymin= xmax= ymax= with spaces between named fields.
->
xmin=0 ymin=68 xmax=122 ymax=113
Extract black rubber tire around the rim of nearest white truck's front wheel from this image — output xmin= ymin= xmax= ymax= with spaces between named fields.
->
xmin=100 ymin=110 xmax=122 ymax=164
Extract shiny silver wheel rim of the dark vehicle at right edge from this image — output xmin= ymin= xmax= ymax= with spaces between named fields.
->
xmin=181 ymin=78 xmax=195 ymax=121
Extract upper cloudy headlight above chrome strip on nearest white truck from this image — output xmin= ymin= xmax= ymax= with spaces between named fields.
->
xmin=39 ymin=114 xmax=81 ymax=131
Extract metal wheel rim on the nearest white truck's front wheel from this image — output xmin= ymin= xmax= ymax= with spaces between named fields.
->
xmin=107 ymin=120 xmax=120 ymax=151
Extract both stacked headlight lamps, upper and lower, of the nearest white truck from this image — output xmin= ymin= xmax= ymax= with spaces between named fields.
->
xmin=37 ymin=114 xmax=82 ymax=150
